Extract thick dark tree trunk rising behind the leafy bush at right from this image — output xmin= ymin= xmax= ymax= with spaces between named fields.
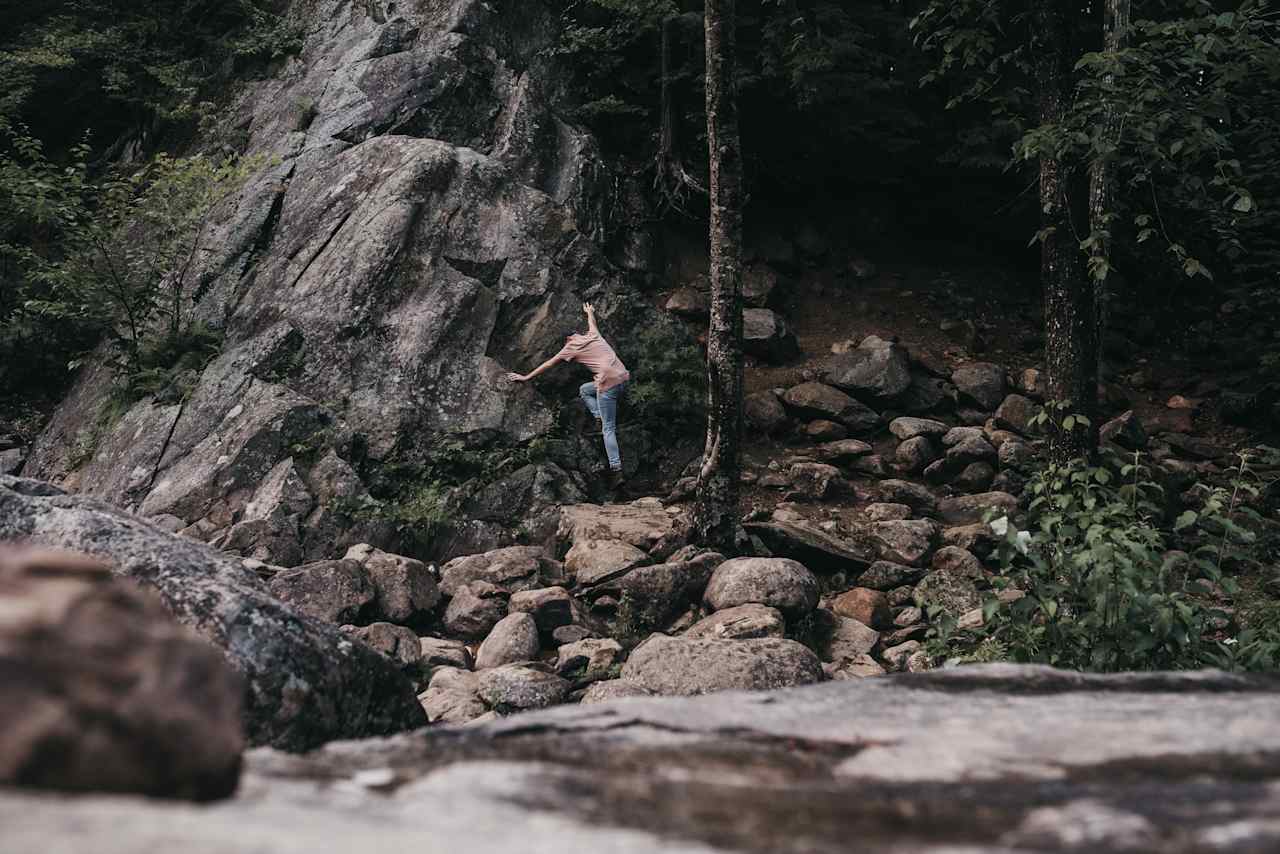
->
xmin=1033 ymin=0 xmax=1098 ymax=462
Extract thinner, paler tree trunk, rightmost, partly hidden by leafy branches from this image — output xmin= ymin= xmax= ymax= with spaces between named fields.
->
xmin=1089 ymin=0 xmax=1129 ymax=376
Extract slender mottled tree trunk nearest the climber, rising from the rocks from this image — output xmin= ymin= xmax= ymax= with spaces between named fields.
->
xmin=690 ymin=0 xmax=742 ymax=551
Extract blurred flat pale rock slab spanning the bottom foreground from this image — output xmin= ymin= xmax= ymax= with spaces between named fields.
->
xmin=0 ymin=665 xmax=1280 ymax=854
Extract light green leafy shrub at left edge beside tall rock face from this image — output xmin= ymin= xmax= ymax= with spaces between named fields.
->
xmin=0 ymin=129 xmax=264 ymax=396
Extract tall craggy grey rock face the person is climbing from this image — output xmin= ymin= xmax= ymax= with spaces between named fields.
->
xmin=26 ymin=0 xmax=680 ymax=566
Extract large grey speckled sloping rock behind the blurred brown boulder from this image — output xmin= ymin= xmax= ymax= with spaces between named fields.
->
xmin=0 ymin=476 xmax=425 ymax=750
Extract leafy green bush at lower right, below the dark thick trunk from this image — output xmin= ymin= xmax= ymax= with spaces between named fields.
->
xmin=931 ymin=445 xmax=1280 ymax=671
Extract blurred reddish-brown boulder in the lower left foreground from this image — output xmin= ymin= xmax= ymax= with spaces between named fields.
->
xmin=0 ymin=549 xmax=244 ymax=804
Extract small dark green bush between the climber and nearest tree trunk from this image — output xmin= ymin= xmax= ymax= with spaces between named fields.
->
xmin=623 ymin=324 xmax=707 ymax=424
